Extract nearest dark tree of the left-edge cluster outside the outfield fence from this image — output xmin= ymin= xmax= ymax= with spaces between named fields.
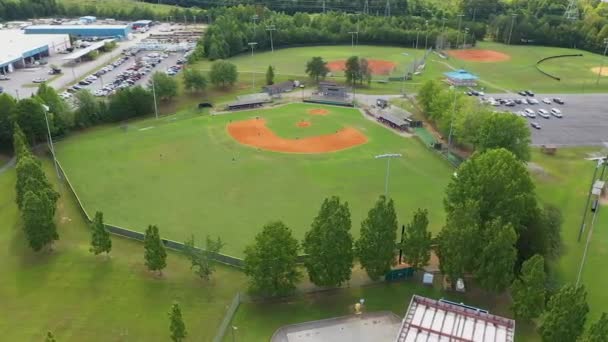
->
xmin=21 ymin=191 xmax=59 ymax=252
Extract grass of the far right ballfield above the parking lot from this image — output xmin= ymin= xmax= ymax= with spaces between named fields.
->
xmin=444 ymin=42 xmax=608 ymax=93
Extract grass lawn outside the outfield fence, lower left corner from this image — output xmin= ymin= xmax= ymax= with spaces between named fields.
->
xmin=0 ymin=163 xmax=245 ymax=341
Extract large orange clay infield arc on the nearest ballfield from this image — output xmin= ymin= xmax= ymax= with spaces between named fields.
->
xmin=228 ymin=119 xmax=367 ymax=153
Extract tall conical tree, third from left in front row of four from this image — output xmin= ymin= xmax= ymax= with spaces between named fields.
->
xmin=355 ymin=196 xmax=397 ymax=280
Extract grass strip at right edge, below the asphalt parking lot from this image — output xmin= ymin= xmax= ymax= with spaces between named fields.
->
xmin=532 ymin=148 xmax=608 ymax=320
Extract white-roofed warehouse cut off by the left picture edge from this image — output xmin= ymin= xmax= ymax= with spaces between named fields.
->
xmin=0 ymin=30 xmax=71 ymax=73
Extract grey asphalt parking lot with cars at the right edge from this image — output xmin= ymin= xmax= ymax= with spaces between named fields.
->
xmin=485 ymin=94 xmax=608 ymax=146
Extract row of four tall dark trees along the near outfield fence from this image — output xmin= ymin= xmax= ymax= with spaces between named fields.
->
xmin=245 ymin=196 xmax=431 ymax=296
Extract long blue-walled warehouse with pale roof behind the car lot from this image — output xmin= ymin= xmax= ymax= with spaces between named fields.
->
xmin=25 ymin=25 xmax=131 ymax=39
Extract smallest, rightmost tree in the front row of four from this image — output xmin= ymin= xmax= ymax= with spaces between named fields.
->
xmin=401 ymin=209 xmax=432 ymax=269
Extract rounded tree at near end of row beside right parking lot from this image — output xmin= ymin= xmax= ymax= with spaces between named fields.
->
xmin=473 ymin=113 xmax=531 ymax=161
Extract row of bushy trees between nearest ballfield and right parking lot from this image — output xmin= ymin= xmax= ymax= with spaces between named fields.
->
xmin=416 ymin=81 xmax=531 ymax=160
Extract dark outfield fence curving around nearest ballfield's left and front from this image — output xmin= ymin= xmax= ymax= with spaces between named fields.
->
xmin=57 ymin=161 xmax=247 ymax=269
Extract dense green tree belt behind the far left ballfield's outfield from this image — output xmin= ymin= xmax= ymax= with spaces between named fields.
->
xmin=199 ymin=6 xmax=468 ymax=60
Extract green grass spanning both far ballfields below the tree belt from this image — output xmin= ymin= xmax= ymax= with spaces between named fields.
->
xmin=193 ymin=42 xmax=608 ymax=94
